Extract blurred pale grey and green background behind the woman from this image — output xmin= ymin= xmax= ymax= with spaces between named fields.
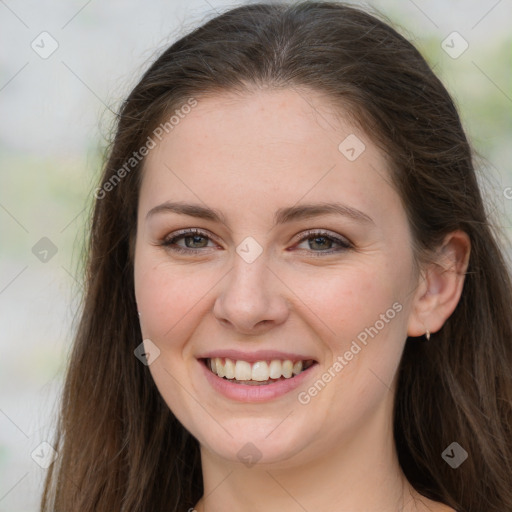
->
xmin=0 ymin=0 xmax=512 ymax=512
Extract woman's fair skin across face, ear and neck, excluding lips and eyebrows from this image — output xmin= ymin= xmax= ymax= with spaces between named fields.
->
xmin=135 ymin=89 xmax=469 ymax=512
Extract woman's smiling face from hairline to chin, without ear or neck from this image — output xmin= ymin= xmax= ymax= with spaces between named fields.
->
xmin=135 ymin=89 xmax=418 ymax=467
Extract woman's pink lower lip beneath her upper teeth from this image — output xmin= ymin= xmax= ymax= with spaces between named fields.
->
xmin=198 ymin=361 xmax=317 ymax=402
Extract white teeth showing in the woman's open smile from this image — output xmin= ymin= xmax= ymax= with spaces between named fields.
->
xmin=202 ymin=357 xmax=318 ymax=386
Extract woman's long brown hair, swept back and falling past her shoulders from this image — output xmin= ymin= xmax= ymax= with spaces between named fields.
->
xmin=42 ymin=2 xmax=512 ymax=512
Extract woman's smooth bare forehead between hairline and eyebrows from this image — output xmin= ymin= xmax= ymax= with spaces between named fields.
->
xmin=140 ymin=89 xmax=397 ymax=226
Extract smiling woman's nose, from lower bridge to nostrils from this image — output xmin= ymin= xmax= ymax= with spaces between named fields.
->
xmin=213 ymin=255 xmax=290 ymax=335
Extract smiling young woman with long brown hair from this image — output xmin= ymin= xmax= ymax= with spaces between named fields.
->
xmin=42 ymin=2 xmax=512 ymax=512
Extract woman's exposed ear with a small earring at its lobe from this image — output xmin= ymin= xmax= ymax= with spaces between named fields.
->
xmin=407 ymin=230 xmax=471 ymax=336
